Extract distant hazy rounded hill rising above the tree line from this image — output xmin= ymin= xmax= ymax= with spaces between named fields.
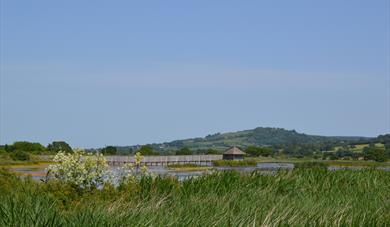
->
xmin=118 ymin=127 xmax=370 ymax=153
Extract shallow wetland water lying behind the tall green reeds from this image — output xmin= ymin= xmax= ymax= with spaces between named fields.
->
xmin=11 ymin=162 xmax=390 ymax=180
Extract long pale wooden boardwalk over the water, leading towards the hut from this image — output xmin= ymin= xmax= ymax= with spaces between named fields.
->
xmin=106 ymin=155 xmax=222 ymax=166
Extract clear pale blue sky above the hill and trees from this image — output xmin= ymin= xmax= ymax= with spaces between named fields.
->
xmin=0 ymin=0 xmax=390 ymax=147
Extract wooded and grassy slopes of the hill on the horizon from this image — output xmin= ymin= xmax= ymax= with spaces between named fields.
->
xmin=122 ymin=127 xmax=370 ymax=155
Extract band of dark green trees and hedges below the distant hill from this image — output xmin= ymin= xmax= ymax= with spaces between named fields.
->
xmin=0 ymin=134 xmax=390 ymax=162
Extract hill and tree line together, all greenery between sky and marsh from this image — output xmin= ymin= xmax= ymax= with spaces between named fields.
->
xmin=0 ymin=131 xmax=390 ymax=162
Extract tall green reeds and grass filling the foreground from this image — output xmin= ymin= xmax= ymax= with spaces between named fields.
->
xmin=0 ymin=169 xmax=390 ymax=226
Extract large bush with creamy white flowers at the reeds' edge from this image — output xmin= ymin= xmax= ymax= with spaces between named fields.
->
xmin=48 ymin=149 xmax=108 ymax=188
